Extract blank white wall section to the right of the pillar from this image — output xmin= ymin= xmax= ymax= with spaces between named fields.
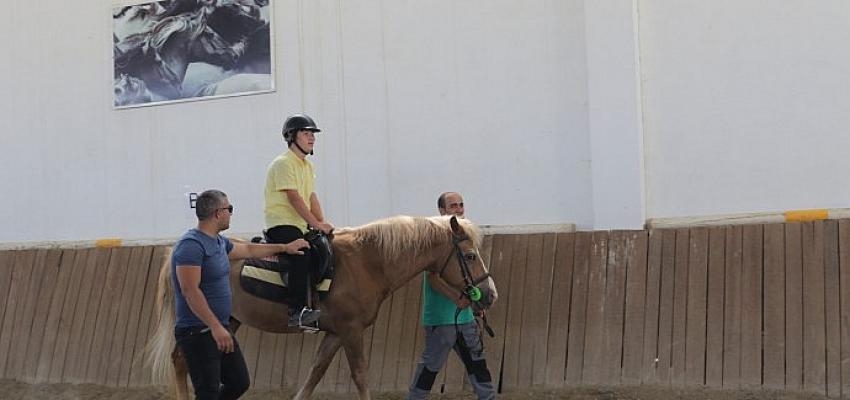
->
xmin=639 ymin=0 xmax=850 ymax=218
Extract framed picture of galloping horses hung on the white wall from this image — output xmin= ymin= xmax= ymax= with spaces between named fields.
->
xmin=112 ymin=0 xmax=274 ymax=108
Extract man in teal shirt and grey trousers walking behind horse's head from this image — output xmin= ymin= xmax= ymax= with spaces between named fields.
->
xmin=407 ymin=192 xmax=496 ymax=400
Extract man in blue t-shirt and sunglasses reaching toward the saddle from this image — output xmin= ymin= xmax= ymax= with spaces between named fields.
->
xmin=171 ymin=190 xmax=309 ymax=400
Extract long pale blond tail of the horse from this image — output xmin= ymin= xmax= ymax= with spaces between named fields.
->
xmin=147 ymin=250 xmax=176 ymax=384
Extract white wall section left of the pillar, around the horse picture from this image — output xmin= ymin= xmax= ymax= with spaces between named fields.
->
xmin=0 ymin=0 xmax=593 ymax=242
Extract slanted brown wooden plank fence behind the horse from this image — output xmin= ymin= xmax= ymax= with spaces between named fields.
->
xmin=0 ymin=220 xmax=850 ymax=397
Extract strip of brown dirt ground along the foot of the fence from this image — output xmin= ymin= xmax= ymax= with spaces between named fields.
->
xmin=0 ymin=380 xmax=827 ymax=400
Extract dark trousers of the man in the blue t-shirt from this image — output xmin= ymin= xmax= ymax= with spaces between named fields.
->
xmin=174 ymin=327 xmax=251 ymax=400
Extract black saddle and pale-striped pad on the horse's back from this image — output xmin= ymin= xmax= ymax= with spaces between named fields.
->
xmin=239 ymin=230 xmax=334 ymax=304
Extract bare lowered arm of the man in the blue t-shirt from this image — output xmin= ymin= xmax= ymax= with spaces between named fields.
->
xmin=176 ymin=265 xmax=233 ymax=353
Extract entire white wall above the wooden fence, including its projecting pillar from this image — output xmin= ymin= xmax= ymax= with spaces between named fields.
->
xmin=8 ymin=0 xmax=850 ymax=243
